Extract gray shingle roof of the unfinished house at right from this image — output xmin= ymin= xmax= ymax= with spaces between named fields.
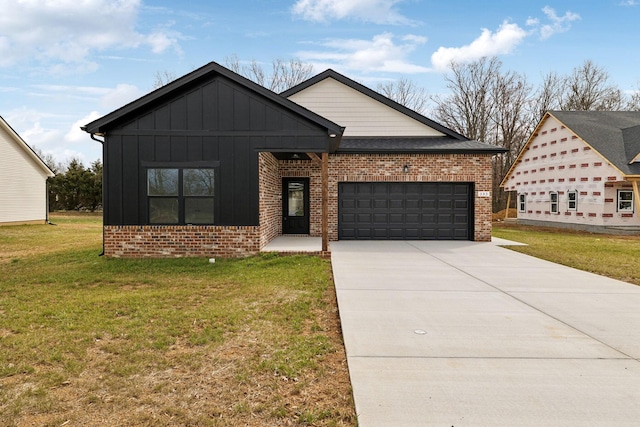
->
xmin=549 ymin=111 xmax=640 ymax=175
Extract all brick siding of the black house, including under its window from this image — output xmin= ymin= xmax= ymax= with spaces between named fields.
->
xmin=104 ymin=153 xmax=492 ymax=258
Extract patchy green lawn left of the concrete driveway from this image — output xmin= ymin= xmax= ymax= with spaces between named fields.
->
xmin=0 ymin=217 xmax=355 ymax=425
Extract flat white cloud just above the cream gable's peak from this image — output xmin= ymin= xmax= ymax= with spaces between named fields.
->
xmin=297 ymin=33 xmax=429 ymax=73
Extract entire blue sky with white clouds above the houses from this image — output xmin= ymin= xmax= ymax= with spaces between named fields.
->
xmin=0 ymin=0 xmax=640 ymax=166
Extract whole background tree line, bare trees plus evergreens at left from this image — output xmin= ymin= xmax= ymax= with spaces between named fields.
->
xmin=43 ymin=55 xmax=640 ymax=211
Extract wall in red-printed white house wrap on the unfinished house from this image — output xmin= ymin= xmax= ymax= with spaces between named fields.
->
xmin=504 ymin=113 xmax=638 ymax=226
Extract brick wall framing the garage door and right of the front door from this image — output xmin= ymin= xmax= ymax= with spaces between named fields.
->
xmin=279 ymin=154 xmax=492 ymax=242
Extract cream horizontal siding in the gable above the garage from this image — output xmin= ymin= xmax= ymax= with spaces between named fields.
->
xmin=289 ymin=78 xmax=444 ymax=137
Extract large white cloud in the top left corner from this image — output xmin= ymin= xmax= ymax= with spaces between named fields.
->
xmin=0 ymin=0 xmax=180 ymax=73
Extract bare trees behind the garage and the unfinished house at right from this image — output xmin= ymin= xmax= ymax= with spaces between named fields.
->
xmin=379 ymin=57 xmax=640 ymax=211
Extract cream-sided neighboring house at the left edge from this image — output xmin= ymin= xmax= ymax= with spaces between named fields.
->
xmin=0 ymin=117 xmax=54 ymax=225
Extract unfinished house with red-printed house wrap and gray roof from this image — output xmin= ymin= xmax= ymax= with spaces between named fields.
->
xmin=501 ymin=111 xmax=640 ymax=232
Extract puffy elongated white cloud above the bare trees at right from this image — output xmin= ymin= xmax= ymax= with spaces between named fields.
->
xmin=431 ymin=21 xmax=528 ymax=71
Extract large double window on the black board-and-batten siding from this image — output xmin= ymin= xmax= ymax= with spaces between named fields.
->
xmin=147 ymin=168 xmax=215 ymax=224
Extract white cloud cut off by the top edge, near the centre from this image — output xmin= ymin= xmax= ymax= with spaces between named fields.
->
xmin=292 ymin=0 xmax=416 ymax=25
